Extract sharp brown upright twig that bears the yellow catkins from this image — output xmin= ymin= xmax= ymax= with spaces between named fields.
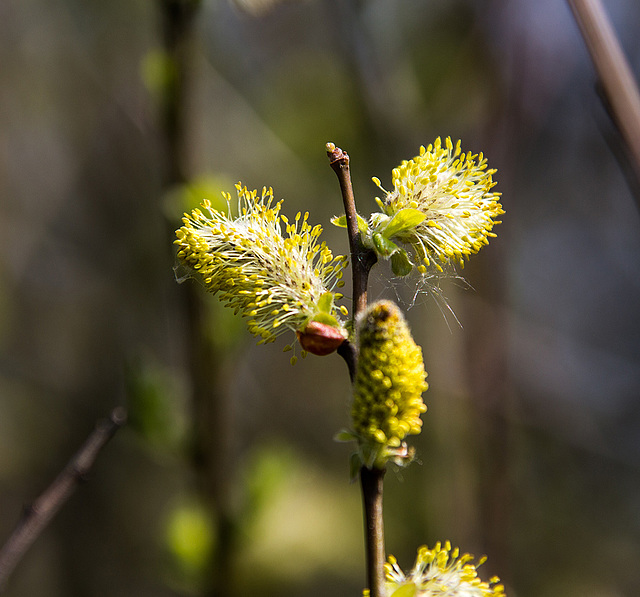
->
xmin=327 ymin=143 xmax=385 ymax=597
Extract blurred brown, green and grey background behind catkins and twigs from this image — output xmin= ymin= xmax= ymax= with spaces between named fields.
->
xmin=0 ymin=0 xmax=640 ymax=597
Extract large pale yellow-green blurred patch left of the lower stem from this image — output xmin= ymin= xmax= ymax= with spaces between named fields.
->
xmin=238 ymin=442 xmax=362 ymax=594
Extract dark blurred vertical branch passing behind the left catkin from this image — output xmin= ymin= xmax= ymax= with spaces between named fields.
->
xmin=158 ymin=0 xmax=233 ymax=597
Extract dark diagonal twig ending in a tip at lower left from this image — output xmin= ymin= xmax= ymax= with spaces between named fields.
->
xmin=0 ymin=408 xmax=127 ymax=593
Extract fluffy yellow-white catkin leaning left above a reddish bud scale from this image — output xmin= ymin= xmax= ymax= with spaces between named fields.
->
xmin=175 ymin=184 xmax=347 ymax=343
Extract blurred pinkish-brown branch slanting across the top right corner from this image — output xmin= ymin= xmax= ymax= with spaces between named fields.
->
xmin=568 ymin=0 xmax=640 ymax=184
